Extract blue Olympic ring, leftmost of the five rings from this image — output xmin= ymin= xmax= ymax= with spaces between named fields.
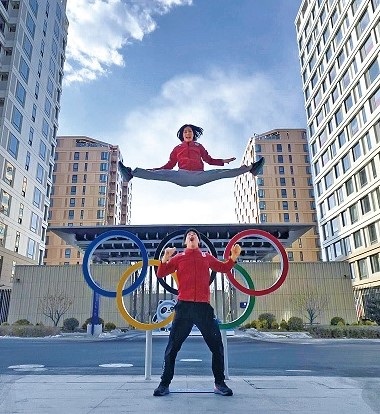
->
xmin=82 ymin=230 xmax=149 ymax=298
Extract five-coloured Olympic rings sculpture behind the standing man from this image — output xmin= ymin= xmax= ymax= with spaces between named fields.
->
xmin=82 ymin=229 xmax=289 ymax=330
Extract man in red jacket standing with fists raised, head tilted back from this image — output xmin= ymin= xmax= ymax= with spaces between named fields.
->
xmin=153 ymin=228 xmax=241 ymax=397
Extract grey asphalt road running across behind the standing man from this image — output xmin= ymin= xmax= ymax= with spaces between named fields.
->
xmin=0 ymin=331 xmax=380 ymax=378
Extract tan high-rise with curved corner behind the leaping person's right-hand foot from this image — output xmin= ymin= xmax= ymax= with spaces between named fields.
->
xmin=234 ymin=129 xmax=321 ymax=262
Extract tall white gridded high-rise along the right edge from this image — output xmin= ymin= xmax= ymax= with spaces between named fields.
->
xmin=295 ymin=0 xmax=380 ymax=317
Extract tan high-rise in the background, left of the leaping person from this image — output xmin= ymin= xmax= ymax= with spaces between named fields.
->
xmin=44 ymin=136 xmax=132 ymax=265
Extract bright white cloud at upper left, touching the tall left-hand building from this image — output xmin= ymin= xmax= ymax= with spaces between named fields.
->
xmin=64 ymin=0 xmax=192 ymax=84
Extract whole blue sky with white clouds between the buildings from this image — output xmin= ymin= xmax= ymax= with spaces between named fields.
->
xmin=58 ymin=0 xmax=306 ymax=225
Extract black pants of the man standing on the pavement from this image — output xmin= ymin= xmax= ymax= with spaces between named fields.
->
xmin=161 ymin=301 xmax=225 ymax=386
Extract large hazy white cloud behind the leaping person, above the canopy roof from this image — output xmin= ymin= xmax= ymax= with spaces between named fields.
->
xmin=112 ymin=70 xmax=304 ymax=224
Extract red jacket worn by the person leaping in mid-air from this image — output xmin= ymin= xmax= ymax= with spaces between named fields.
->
xmin=153 ymin=141 xmax=224 ymax=171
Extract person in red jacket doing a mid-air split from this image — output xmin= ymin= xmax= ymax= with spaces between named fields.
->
xmin=119 ymin=124 xmax=265 ymax=187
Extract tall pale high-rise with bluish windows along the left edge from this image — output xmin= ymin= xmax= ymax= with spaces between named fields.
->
xmin=0 ymin=0 xmax=68 ymax=287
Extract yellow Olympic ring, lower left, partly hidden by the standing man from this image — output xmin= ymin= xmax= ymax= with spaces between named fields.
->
xmin=116 ymin=259 xmax=178 ymax=330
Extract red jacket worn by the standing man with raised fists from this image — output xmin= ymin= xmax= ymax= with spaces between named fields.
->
xmin=157 ymin=249 xmax=235 ymax=302
